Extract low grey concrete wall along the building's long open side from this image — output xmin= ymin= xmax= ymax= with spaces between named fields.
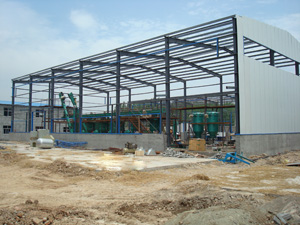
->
xmin=9 ymin=133 xmax=166 ymax=151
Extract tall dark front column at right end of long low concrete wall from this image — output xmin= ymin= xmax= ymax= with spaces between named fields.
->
xmin=165 ymin=37 xmax=171 ymax=147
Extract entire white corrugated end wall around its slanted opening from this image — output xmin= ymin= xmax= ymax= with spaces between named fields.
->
xmin=237 ymin=17 xmax=300 ymax=134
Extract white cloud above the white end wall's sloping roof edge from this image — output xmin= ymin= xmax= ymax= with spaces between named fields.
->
xmin=265 ymin=13 xmax=300 ymax=41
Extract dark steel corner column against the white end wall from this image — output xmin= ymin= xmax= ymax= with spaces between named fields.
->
xmin=232 ymin=18 xmax=240 ymax=134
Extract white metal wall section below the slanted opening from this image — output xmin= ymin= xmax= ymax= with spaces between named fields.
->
xmin=239 ymin=56 xmax=300 ymax=134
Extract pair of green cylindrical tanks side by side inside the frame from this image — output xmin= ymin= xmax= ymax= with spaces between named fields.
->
xmin=193 ymin=112 xmax=219 ymax=138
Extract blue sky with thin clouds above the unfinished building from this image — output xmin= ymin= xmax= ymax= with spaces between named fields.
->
xmin=0 ymin=0 xmax=300 ymax=100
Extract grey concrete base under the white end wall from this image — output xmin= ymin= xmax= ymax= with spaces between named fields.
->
xmin=235 ymin=133 xmax=300 ymax=156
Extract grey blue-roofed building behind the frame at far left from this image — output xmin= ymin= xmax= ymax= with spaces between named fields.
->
xmin=0 ymin=101 xmax=69 ymax=141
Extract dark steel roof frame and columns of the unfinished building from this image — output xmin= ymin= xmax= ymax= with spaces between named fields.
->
xmin=11 ymin=15 xmax=299 ymax=145
